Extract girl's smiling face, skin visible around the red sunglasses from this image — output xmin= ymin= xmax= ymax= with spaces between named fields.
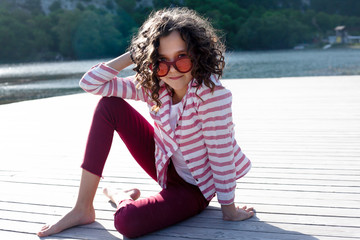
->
xmin=158 ymin=31 xmax=193 ymax=101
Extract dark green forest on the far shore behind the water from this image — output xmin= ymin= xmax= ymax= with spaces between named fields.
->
xmin=0 ymin=0 xmax=360 ymax=63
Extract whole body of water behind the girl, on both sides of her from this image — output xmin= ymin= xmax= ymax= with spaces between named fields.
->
xmin=0 ymin=49 xmax=360 ymax=104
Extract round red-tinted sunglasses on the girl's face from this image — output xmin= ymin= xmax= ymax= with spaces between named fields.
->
xmin=149 ymin=56 xmax=192 ymax=77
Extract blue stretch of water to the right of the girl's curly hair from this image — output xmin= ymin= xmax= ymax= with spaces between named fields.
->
xmin=224 ymin=49 xmax=360 ymax=78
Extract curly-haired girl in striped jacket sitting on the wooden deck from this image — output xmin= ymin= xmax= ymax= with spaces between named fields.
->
xmin=38 ymin=8 xmax=254 ymax=238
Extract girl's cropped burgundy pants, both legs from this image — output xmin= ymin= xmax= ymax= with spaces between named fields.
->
xmin=82 ymin=97 xmax=209 ymax=238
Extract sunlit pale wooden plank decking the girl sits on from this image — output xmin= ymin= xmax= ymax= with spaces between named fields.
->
xmin=0 ymin=76 xmax=360 ymax=240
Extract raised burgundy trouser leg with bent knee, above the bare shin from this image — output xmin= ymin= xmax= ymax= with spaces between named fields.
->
xmin=82 ymin=97 xmax=156 ymax=180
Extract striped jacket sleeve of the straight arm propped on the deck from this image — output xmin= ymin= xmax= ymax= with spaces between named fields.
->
xmin=198 ymin=86 xmax=236 ymax=205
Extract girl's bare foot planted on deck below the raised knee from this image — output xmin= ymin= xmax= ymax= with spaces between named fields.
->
xmin=37 ymin=207 xmax=95 ymax=237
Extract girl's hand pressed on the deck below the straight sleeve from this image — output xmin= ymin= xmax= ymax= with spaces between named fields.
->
xmin=221 ymin=204 xmax=254 ymax=221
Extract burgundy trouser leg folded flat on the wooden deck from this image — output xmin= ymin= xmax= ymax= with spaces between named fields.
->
xmin=115 ymin=165 xmax=209 ymax=238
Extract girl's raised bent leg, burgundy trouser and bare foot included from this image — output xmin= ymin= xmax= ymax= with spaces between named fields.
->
xmin=38 ymin=98 xmax=156 ymax=237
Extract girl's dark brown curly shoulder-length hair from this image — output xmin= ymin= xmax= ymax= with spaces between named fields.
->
xmin=130 ymin=7 xmax=225 ymax=109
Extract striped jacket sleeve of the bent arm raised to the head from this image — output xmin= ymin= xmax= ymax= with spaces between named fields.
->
xmin=79 ymin=63 xmax=148 ymax=102
